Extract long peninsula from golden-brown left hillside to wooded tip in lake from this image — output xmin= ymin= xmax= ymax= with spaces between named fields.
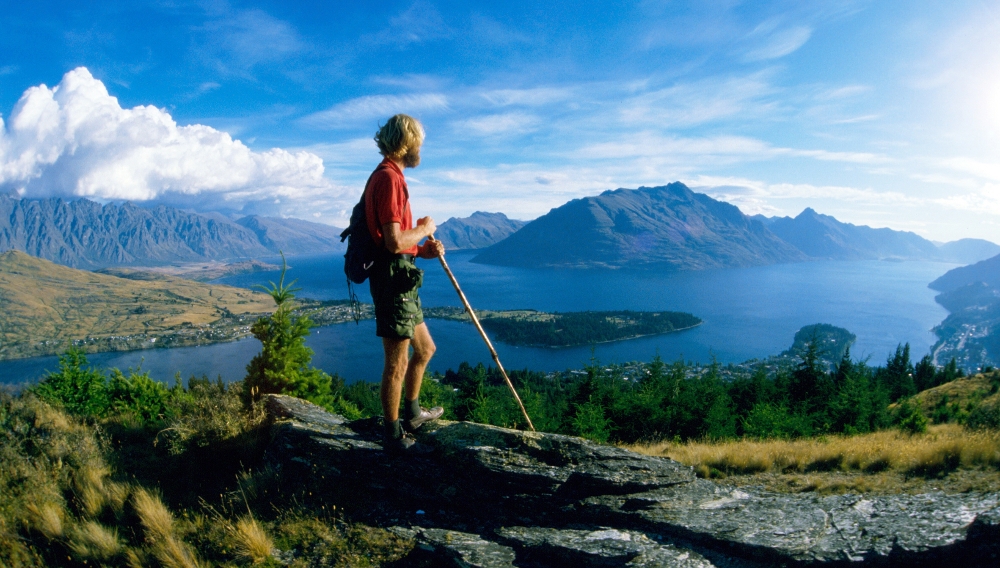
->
xmin=0 ymin=251 xmax=702 ymax=360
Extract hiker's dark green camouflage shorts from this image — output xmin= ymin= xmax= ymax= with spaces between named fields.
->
xmin=369 ymin=257 xmax=424 ymax=339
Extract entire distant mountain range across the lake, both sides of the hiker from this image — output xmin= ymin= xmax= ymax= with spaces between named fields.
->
xmin=0 ymin=187 xmax=1000 ymax=270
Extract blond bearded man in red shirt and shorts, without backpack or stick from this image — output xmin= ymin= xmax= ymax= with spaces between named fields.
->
xmin=365 ymin=114 xmax=444 ymax=454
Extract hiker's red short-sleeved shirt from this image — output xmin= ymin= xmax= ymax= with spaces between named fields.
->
xmin=365 ymin=158 xmax=417 ymax=255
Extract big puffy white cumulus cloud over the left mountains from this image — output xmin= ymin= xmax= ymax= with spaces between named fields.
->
xmin=0 ymin=67 xmax=332 ymax=208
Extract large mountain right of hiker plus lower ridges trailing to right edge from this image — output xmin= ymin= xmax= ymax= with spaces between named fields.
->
xmin=473 ymin=182 xmax=1000 ymax=270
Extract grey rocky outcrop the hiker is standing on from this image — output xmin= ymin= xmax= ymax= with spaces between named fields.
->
xmin=268 ymin=396 xmax=1000 ymax=567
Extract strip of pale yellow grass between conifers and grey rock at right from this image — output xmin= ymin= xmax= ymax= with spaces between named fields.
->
xmin=630 ymin=424 xmax=1000 ymax=477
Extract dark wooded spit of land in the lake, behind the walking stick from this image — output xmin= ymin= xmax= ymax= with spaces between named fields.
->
xmin=424 ymin=308 xmax=702 ymax=347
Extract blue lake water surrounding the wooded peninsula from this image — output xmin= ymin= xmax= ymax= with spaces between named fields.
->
xmin=0 ymin=253 xmax=956 ymax=383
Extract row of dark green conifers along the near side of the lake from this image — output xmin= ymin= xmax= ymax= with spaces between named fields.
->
xmin=334 ymin=342 xmax=963 ymax=443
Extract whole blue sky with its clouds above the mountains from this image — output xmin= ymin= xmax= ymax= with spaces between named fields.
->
xmin=0 ymin=0 xmax=1000 ymax=242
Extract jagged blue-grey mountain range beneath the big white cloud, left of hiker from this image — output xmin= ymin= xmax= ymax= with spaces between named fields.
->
xmin=0 ymin=195 xmax=343 ymax=268
